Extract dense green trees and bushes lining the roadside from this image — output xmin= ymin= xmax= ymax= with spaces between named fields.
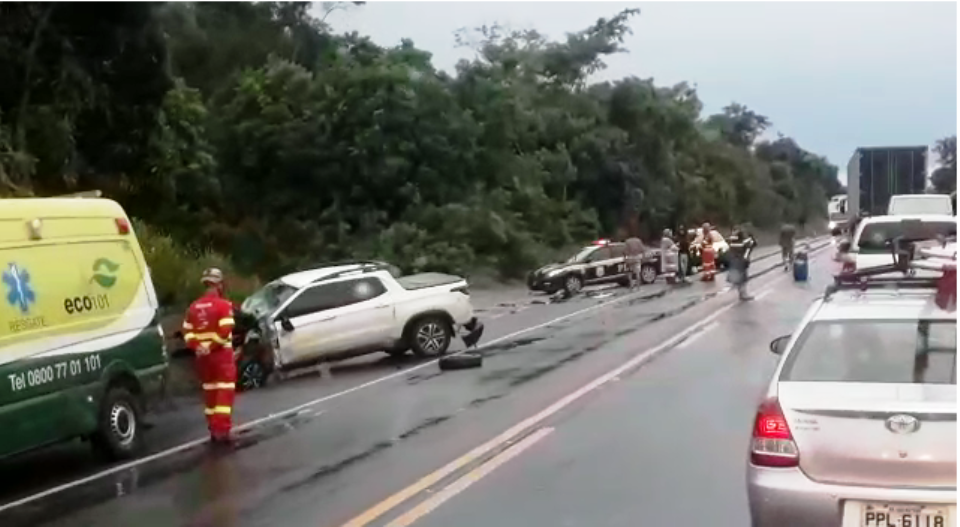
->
xmin=0 ymin=2 xmax=860 ymax=304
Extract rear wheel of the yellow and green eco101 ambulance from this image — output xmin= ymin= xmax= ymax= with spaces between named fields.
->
xmin=90 ymin=386 xmax=144 ymax=461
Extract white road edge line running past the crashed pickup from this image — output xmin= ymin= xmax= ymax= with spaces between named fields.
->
xmin=0 ymin=237 xmax=828 ymax=512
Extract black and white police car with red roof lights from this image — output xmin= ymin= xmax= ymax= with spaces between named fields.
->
xmin=527 ymin=240 xmax=660 ymax=295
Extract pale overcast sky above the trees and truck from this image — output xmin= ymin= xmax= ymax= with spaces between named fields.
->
xmin=327 ymin=1 xmax=957 ymax=185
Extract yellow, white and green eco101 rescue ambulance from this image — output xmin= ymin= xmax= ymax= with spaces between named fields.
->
xmin=0 ymin=198 xmax=167 ymax=459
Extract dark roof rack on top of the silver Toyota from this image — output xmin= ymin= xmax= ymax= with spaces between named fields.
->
xmin=823 ymin=236 xmax=957 ymax=309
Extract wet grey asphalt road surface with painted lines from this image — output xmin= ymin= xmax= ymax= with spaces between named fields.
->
xmin=0 ymin=240 xmax=825 ymax=527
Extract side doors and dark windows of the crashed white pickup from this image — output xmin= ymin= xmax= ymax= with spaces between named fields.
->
xmin=275 ymin=277 xmax=393 ymax=363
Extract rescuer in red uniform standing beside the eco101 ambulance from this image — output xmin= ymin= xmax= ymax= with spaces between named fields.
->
xmin=183 ymin=268 xmax=237 ymax=443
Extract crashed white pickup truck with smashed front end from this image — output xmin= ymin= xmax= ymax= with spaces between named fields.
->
xmin=238 ymin=262 xmax=483 ymax=389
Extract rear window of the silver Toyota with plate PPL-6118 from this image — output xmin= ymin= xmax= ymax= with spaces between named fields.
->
xmin=780 ymin=320 xmax=957 ymax=384
